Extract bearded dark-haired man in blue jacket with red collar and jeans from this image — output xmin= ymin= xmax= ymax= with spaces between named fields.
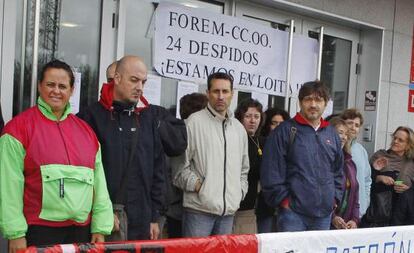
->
xmin=260 ymin=81 xmax=344 ymax=232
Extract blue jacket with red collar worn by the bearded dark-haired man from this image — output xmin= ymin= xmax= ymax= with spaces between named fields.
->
xmin=260 ymin=113 xmax=344 ymax=217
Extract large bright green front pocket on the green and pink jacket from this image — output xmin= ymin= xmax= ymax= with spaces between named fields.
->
xmin=39 ymin=164 xmax=94 ymax=223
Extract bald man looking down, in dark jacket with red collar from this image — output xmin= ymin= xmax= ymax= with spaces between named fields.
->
xmin=78 ymin=56 xmax=165 ymax=240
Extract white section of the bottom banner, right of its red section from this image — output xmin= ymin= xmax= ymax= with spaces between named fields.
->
xmin=257 ymin=226 xmax=414 ymax=253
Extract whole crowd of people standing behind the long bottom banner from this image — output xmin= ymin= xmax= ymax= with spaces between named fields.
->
xmin=0 ymin=56 xmax=414 ymax=253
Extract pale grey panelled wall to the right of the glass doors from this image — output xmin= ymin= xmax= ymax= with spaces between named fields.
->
xmin=278 ymin=0 xmax=414 ymax=150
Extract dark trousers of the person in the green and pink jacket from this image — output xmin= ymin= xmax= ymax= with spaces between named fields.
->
xmin=26 ymin=225 xmax=91 ymax=246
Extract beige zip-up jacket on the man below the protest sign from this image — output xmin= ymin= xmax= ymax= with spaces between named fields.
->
xmin=172 ymin=105 xmax=249 ymax=215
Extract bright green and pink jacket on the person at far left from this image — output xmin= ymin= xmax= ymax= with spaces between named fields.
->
xmin=0 ymin=98 xmax=113 ymax=239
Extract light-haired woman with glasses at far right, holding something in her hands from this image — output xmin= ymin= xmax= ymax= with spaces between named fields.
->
xmin=363 ymin=126 xmax=414 ymax=227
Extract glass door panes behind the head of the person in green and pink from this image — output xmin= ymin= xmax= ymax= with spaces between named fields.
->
xmin=13 ymin=0 xmax=102 ymax=115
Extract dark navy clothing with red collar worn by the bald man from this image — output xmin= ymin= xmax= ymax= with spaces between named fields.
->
xmin=78 ymin=85 xmax=165 ymax=240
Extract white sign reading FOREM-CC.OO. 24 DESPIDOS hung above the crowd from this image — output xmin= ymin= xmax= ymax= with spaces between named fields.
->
xmin=153 ymin=2 xmax=289 ymax=96
